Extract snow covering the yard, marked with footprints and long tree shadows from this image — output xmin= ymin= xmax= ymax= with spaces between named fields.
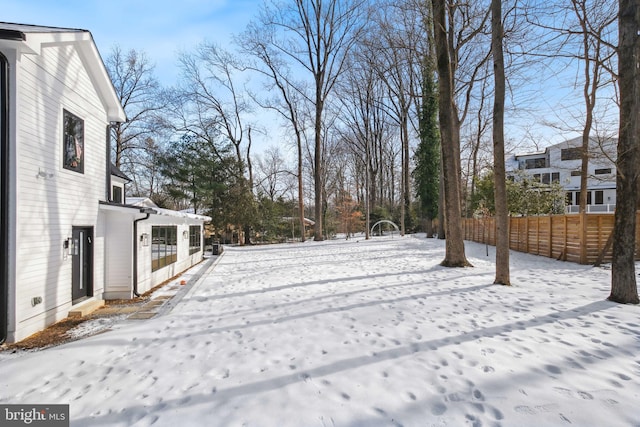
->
xmin=0 ymin=235 xmax=640 ymax=427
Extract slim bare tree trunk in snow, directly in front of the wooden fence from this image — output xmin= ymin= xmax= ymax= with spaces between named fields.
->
xmin=491 ymin=0 xmax=511 ymax=285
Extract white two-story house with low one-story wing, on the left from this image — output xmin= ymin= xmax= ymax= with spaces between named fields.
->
xmin=0 ymin=23 xmax=207 ymax=342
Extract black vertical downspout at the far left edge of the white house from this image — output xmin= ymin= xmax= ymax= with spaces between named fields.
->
xmin=0 ymin=52 xmax=9 ymax=344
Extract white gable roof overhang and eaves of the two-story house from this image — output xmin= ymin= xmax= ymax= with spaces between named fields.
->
xmin=0 ymin=22 xmax=127 ymax=122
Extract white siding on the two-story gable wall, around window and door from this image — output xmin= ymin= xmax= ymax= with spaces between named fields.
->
xmin=11 ymin=46 xmax=107 ymax=339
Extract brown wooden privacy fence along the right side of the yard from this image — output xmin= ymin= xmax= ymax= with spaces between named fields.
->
xmin=462 ymin=211 xmax=640 ymax=264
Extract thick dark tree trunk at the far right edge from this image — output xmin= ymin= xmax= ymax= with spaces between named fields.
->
xmin=609 ymin=0 xmax=640 ymax=304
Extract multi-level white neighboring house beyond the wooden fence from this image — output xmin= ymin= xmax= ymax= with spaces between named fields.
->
xmin=506 ymin=138 xmax=617 ymax=213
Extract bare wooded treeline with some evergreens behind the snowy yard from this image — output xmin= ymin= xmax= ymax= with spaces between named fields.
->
xmin=106 ymin=0 xmax=638 ymax=300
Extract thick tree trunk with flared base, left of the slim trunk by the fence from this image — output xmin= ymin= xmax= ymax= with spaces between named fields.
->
xmin=432 ymin=0 xmax=470 ymax=267
